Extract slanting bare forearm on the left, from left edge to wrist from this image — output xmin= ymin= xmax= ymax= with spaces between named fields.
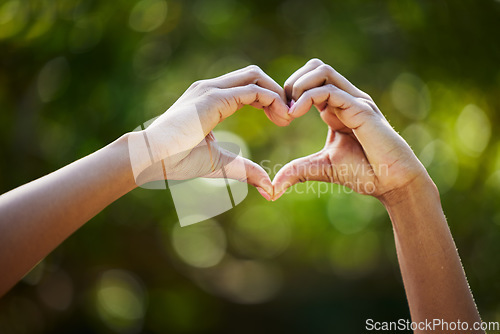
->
xmin=0 ymin=135 xmax=135 ymax=296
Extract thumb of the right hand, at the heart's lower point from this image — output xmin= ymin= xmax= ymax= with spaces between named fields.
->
xmin=273 ymin=152 xmax=332 ymax=201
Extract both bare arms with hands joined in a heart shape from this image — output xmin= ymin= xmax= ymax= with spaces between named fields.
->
xmin=0 ymin=59 xmax=482 ymax=333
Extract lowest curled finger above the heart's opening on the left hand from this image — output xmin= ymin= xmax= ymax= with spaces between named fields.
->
xmin=214 ymin=84 xmax=292 ymax=126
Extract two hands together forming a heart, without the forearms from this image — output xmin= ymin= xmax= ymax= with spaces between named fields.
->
xmin=131 ymin=59 xmax=427 ymax=201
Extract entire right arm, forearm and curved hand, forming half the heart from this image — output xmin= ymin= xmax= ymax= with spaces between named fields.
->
xmin=273 ymin=59 xmax=484 ymax=333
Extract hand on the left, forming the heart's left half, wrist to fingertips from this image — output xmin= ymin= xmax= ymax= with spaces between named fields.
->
xmin=129 ymin=65 xmax=292 ymax=200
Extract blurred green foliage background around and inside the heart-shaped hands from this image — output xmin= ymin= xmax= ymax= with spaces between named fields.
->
xmin=0 ymin=0 xmax=500 ymax=333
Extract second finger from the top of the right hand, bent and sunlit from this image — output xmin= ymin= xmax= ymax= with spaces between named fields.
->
xmin=292 ymin=64 xmax=371 ymax=100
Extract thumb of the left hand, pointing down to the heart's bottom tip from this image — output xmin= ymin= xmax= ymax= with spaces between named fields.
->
xmin=206 ymin=148 xmax=273 ymax=201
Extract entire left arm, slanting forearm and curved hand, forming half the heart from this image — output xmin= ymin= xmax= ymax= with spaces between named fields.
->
xmin=0 ymin=65 xmax=292 ymax=296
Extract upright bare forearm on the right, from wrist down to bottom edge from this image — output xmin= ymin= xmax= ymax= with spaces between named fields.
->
xmin=382 ymin=178 xmax=483 ymax=333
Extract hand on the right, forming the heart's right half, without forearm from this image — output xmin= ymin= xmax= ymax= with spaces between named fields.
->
xmin=273 ymin=59 xmax=430 ymax=202
